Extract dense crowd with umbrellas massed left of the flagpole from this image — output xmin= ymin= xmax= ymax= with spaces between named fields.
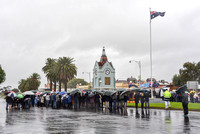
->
xmin=5 ymin=90 xmax=149 ymax=112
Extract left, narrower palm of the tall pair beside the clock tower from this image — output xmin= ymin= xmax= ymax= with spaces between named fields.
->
xmin=42 ymin=58 xmax=57 ymax=90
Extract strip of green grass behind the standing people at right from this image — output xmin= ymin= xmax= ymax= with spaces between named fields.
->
xmin=127 ymin=102 xmax=200 ymax=110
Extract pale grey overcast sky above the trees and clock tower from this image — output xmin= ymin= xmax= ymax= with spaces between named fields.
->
xmin=0 ymin=0 xmax=200 ymax=87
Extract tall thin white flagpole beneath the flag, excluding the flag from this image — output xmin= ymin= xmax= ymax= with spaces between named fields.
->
xmin=149 ymin=8 xmax=153 ymax=98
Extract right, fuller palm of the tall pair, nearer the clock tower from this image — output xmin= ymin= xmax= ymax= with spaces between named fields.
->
xmin=58 ymin=57 xmax=77 ymax=91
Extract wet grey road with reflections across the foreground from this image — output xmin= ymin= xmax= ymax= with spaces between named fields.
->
xmin=0 ymin=98 xmax=200 ymax=134
